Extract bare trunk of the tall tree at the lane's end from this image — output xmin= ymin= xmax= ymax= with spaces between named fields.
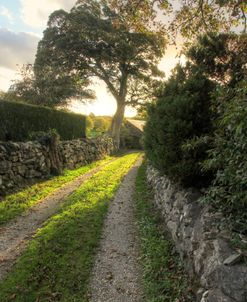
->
xmin=111 ymin=102 xmax=125 ymax=150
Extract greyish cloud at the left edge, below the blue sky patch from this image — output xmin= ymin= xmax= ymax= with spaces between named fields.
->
xmin=0 ymin=28 xmax=40 ymax=70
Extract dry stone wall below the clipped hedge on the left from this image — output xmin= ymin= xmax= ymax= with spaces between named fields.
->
xmin=0 ymin=137 xmax=113 ymax=195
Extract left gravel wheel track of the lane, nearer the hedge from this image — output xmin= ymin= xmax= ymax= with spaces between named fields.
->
xmin=0 ymin=159 xmax=115 ymax=280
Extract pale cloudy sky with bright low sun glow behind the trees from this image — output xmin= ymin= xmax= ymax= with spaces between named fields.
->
xmin=0 ymin=0 xmax=185 ymax=116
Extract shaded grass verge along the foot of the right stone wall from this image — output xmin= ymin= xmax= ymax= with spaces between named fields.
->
xmin=135 ymin=165 xmax=194 ymax=302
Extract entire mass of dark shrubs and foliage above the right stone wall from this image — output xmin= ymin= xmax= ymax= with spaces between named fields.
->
xmin=145 ymin=33 xmax=247 ymax=234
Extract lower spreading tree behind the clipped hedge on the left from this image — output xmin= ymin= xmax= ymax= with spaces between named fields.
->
xmin=5 ymin=64 xmax=94 ymax=107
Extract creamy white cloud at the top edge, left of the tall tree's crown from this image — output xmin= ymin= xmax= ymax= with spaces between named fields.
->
xmin=21 ymin=0 xmax=76 ymax=28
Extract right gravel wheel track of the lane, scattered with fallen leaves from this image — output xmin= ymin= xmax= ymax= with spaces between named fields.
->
xmin=90 ymin=159 xmax=143 ymax=302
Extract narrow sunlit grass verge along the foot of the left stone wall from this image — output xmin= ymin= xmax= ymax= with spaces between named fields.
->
xmin=0 ymin=157 xmax=112 ymax=225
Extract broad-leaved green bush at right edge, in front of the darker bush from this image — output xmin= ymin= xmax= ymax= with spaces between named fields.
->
xmin=204 ymin=81 xmax=247 ymax=234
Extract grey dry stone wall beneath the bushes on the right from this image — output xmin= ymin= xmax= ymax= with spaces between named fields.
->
xmin=147 ymin=166 xmax=247 ymax=302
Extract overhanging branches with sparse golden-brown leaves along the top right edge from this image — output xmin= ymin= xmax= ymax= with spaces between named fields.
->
xmin=109 ymin=0 xmax=247 ymax=40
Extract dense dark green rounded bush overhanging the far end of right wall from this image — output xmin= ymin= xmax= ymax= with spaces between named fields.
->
xmin=144 ymin=65 xmax=214 ymax=186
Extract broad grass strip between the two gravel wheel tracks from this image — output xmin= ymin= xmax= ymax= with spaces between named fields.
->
xmin=0 ymin=153 xmax=139 ymax=302
